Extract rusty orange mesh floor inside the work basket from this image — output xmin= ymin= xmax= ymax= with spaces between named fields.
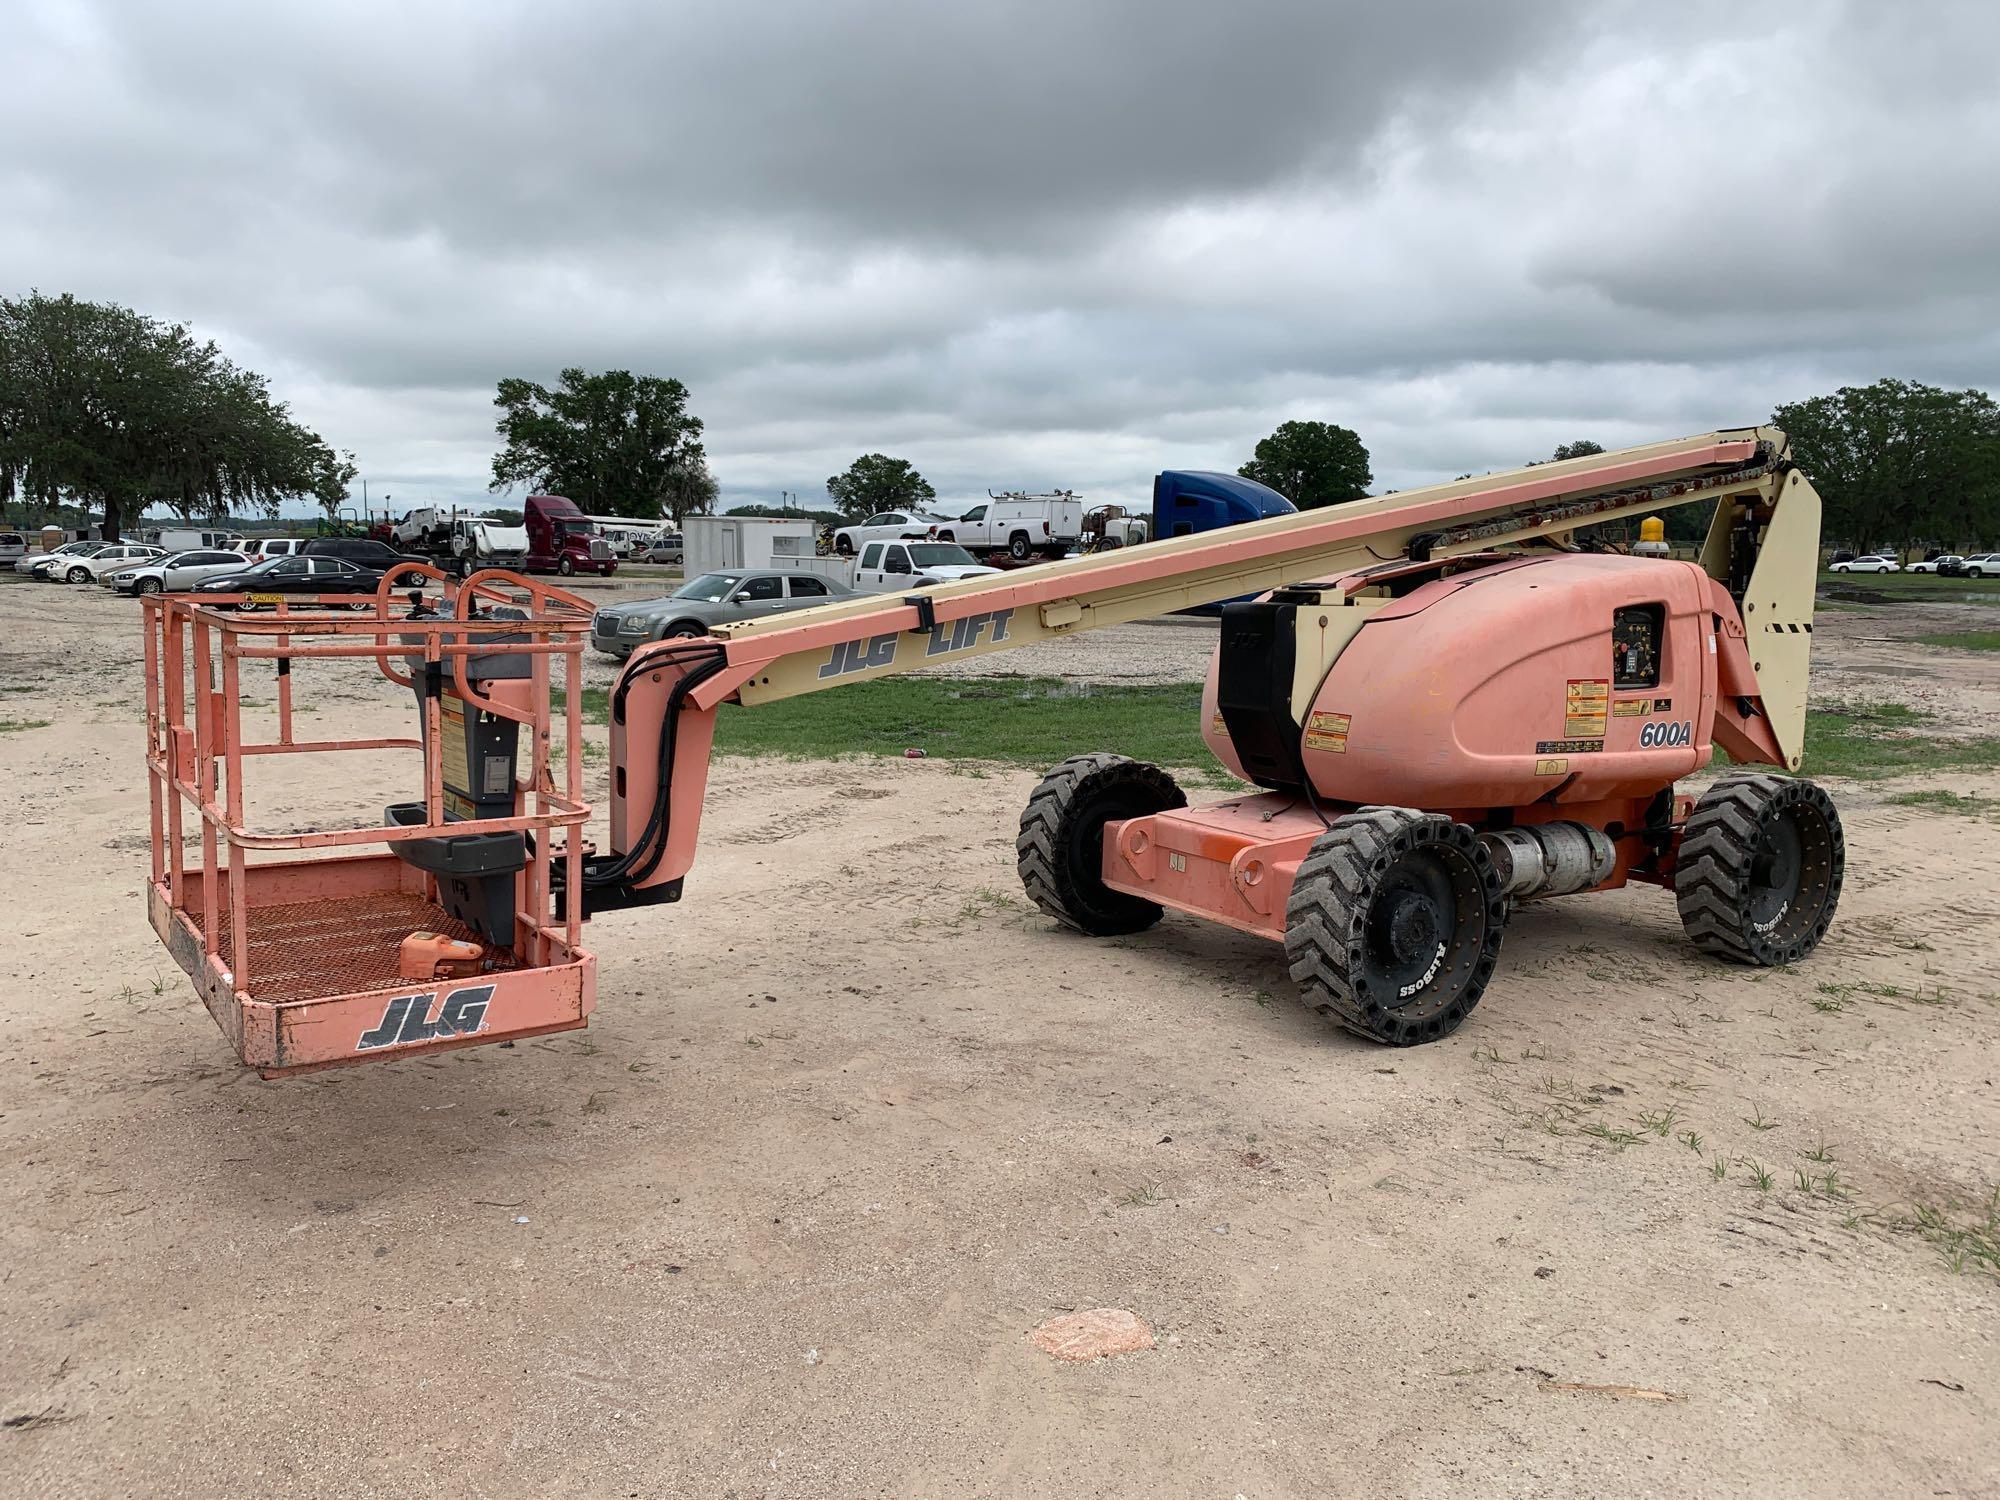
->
xmin=188 ymin=886 xmax=520 ymax=1006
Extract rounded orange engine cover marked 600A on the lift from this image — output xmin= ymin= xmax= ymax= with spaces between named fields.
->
xmin=1204 ymin=552 xmax=1742 ymax=810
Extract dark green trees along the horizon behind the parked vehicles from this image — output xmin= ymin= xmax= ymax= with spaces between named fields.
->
xmin=0 ymin=292 xmax=2000 ymax=550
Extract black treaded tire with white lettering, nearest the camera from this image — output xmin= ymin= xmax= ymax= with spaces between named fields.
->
xmin=1284 ymin=808 xmax=1506 ymax=1046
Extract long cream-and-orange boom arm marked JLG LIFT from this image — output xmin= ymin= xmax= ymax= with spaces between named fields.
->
xmin=582 ymin=428 xmax=1820 ymax=912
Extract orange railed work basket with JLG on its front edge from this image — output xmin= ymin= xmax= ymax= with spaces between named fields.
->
xmin=144 ymin=564 xmax=596 ymax=1078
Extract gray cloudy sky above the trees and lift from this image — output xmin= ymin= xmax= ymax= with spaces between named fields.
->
xmin=0 ymin=0 xmax=2000 ymax=504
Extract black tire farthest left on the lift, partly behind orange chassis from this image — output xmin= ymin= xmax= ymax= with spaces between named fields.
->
xmin=1014 ymin=750 xmax=1188 ymax=938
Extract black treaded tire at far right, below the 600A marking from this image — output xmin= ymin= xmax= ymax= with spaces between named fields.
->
xmin=1674 ymin=776 xmax=1848 ymax=968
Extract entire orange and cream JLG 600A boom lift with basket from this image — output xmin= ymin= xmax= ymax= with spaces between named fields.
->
xmin=146 ymin=428 xmax=1844 ymax=1076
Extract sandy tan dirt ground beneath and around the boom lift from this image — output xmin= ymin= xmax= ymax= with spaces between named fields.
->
xmin=0 ymin=578 xmax=2000 ymax=1500
